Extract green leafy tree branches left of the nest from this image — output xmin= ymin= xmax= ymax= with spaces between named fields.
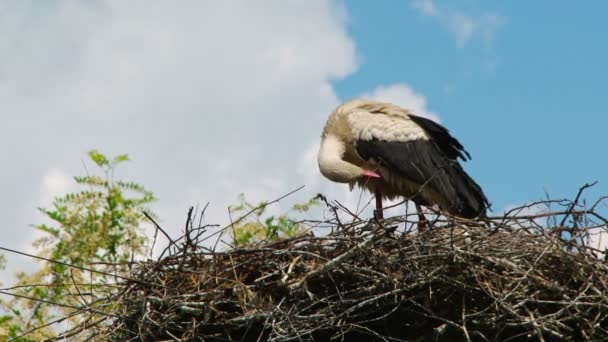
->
xmin=0 ymin=150 xmax=155 ymax=341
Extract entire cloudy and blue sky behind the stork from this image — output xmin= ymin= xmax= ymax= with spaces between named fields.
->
xmin=0 ymin=0 xmax=608 ymax=276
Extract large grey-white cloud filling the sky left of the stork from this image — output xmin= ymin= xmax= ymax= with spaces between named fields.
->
xmin=0 ymin=0 xmax=357 ymax=280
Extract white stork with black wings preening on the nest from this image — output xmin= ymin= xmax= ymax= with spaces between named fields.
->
xmin=318 ymin=100 xmax=489 ymax=220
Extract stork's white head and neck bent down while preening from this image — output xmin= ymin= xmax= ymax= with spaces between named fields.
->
xmin=318 ymin=135 xmax=363 ymax=183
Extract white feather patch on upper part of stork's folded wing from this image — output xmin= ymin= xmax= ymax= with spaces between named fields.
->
xmin=347 ymin=111 xmax=429 ymax=142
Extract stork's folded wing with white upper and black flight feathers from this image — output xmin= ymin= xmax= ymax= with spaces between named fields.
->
xmin=349 ymin=113 xmax=487 ymax=217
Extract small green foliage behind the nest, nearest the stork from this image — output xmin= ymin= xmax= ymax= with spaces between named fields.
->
xmin=230 ymin=194 xmax=318 ymax=246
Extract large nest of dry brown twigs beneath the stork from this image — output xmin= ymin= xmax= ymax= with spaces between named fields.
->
xmin=58 ymin=188 xmax=608 ymax=341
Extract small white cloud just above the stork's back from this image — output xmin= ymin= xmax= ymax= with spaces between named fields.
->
xmin=361 ymin=83 xmax=439 ymax=122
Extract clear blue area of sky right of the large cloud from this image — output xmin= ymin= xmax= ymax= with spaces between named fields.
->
xmin=335 ymin=0 xmax=608 ymax=209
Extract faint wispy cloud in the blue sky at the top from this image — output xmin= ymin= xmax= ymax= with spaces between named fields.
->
xmin=410 ymin=0 xmax=505 ymax=48
